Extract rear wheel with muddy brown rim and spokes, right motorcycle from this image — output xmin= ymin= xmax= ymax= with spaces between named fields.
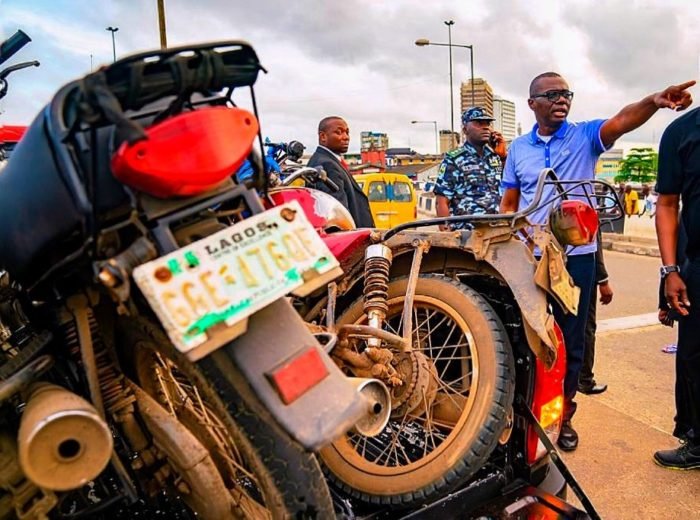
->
xmin=321 ymin=274 xmax=515 ymax=508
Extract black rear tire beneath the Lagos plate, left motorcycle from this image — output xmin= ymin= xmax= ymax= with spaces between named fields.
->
xmin=118 ymin=317 xmax=334 ymax=519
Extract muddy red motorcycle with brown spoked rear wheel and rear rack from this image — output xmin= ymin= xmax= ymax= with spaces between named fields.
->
xmin=269 ymin=165 xmax=622 ymax=508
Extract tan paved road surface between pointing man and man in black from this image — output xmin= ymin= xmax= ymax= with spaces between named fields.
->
xmin=565 ymin=252 xmax=700 ymax=520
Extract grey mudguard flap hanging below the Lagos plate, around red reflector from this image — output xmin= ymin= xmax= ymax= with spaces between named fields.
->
xmin=211 ymin=298 xmax=367 ymax=451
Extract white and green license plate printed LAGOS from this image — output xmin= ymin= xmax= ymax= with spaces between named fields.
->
xmin=134 ymin=201 xmax=342 ymax=360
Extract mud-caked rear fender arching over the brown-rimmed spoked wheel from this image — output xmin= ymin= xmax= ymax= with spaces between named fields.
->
xmin=385 ymin=229 xmax=557 ymax=368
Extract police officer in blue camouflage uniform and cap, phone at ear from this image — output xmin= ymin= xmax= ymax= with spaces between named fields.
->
xmin=433 ymin=107 xmax=505 ymax=230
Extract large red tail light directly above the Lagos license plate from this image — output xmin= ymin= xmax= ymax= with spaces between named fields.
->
xmin=112 ymin=107 xmax=258 ymax=198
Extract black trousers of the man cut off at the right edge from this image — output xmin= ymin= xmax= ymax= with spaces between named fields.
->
xmin=674 ymin=258 xmax=700 ymax=445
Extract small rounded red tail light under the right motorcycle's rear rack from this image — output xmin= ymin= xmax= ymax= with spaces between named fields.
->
xmin=549 ymin=200 xmax=598 ymax=246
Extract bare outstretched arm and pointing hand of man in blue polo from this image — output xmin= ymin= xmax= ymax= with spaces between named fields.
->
xmin=600 ymin=80 xmax=695 ymax=147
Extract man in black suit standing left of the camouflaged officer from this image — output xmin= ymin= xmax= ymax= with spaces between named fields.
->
xmin=309 ymin=116 xmax=374 ymax=227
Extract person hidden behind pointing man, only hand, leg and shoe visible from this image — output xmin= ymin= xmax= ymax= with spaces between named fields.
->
xmin=578 ymin=234 xmax=613 ymax=395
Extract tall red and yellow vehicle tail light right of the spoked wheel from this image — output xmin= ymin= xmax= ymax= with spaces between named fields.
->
xmin=527 ymin=323 xmax=566 ymax=464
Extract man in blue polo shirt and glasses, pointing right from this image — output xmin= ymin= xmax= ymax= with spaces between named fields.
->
xmin=501 ymin=72 xmax=695 ymax=451
